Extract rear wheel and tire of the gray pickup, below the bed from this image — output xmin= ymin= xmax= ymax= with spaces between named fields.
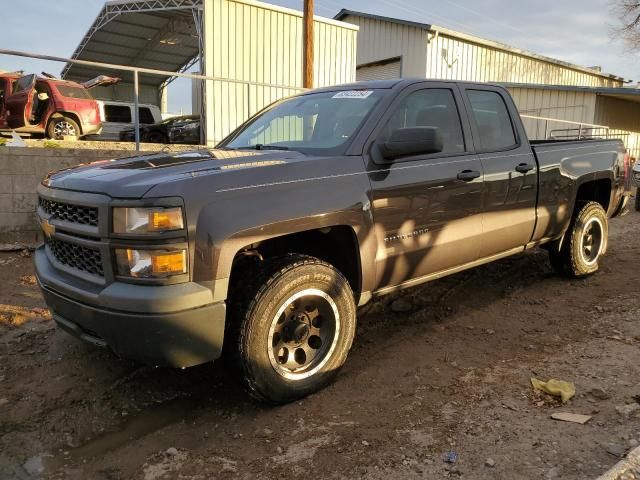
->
xmin=549 ymin=202 xmax=609 ymax=278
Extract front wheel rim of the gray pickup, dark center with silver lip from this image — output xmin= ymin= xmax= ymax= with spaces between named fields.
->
xmin=267 ymin=288 xmax=340 ymax=380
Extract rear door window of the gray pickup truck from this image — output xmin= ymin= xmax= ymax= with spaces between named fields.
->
xmin=467 ymin=90 xmax=516 ymax=150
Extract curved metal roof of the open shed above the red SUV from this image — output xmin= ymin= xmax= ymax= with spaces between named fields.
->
xmin=62 ymin=0 xmax=203 ymax=86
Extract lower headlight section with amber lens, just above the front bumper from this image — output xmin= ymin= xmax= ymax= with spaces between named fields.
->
xmin=116 ymin=249 xmax=187 ymax=278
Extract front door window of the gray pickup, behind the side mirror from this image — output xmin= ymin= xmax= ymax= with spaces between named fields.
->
xmin=383 ymin=88 xmax=465 ymax=153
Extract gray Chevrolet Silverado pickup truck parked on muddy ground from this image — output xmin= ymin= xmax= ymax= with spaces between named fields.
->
xmin=35 ymin=80 xmax=631 ymax=403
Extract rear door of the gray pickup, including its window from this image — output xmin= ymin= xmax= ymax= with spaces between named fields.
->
xmin=462 ymin=85 xmax=538 ymax=258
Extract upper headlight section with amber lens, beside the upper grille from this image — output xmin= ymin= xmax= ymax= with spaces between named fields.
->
xmin=113 ymin=207 xmax=184 ymax=234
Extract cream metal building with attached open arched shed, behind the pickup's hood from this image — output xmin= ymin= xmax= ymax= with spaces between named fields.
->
xmin=62 ymin=0 xmax=358 ymax=144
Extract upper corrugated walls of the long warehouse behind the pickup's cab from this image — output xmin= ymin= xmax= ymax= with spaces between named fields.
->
xmin=345 ymin=15 xmax=622 ymax=87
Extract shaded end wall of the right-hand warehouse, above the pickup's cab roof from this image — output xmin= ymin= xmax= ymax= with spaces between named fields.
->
xmin=346 ymin=15 xmax=427 ymax=77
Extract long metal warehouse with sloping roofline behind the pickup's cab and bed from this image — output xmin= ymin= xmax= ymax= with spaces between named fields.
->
xmin=335 ymin=10 xmax=640 ymax=157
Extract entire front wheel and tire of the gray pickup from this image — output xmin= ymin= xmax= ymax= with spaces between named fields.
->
xmin=227 ymin=254 xmax=356 ymax=404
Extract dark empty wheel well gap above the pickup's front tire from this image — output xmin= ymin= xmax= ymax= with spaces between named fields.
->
xmin=230 ymin=225 xmax=362 ymax=294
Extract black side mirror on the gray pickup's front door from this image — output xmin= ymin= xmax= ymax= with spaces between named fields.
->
xmin=380 ymin=127 xmax=444 ymax=160
